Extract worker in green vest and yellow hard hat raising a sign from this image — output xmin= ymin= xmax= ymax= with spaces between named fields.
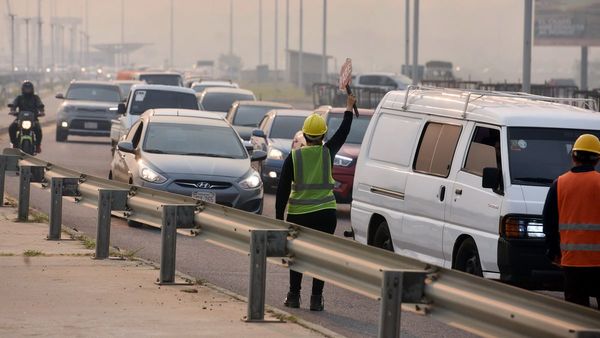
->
xmin=275 ymin=95 xmax=356 ymax=311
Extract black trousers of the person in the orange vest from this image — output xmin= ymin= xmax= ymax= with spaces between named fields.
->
xmin=563 ymin=267 xmax=600 ymax=308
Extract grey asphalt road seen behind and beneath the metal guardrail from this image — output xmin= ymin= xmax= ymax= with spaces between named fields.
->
xmin=0 ymin=125 xmax=470 ymax=337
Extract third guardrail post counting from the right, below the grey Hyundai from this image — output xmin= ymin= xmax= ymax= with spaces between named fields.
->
xmin=158 ymin=205 xmax=196 ymax=285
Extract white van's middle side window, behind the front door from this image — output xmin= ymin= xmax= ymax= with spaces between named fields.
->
xmin=413 ymin=122 xmax=462 ymax=177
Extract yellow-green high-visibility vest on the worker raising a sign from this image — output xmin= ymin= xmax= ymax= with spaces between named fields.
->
xmin=288 ymin=145 xmax=337 ymax=215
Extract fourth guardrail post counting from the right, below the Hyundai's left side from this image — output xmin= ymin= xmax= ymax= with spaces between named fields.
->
xmin=94 ymin=189 xmax=129 ymax=259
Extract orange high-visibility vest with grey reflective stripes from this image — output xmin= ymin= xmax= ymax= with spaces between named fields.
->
xmin=558 ymin=170 xmax=600 ymax=267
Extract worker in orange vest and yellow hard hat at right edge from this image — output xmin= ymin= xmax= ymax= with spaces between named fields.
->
xmin=543 ymin=134 xmax=600 ymax=306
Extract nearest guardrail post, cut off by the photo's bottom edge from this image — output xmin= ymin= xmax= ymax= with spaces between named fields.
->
xmin=377 ymin=271 xmax=426 ymax=338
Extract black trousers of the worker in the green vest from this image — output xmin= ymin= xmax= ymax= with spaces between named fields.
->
xmin=287 ymin=209 xmax=337 ymax=295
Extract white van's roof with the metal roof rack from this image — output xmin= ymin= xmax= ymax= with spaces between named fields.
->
xmin=380 ymin=88 xmax=600 ymax=129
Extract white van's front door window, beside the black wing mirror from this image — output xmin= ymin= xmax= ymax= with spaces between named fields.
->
xmin=463 ymin=127 xmax=502 ymax=176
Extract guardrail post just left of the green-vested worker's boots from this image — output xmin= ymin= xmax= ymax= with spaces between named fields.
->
xmin=246 ymin=230 xmax=288 ymax=322
